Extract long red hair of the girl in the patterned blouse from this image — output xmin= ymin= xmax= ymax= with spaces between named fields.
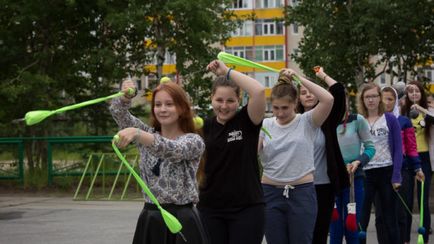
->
xmin=151 ymin=82 xmax=195 ymax=133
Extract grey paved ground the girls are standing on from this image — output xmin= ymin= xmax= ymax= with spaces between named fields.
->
xmin=0 ymin=194 xmax=432 ymax=244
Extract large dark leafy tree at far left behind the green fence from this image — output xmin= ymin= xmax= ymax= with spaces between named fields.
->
xmin=0 ymin=0 xmax=150 ymax=171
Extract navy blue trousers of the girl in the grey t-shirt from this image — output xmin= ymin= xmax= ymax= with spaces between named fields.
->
xmin=262 ymin=183 xmax=317 ymax=244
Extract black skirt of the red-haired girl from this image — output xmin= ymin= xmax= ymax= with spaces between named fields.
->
xmin=133 ymin=203 xmax=209 ymax=244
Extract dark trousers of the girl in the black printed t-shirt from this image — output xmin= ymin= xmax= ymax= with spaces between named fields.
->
xmin=199 ymin=204 xmax=265 ymax=244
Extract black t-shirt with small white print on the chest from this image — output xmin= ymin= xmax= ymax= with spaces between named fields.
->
xmin=198 ymin=106 xmax=263 ymax=208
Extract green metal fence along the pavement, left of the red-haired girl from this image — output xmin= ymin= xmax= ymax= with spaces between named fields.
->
xmin=0 ymin=136 xmax=140 ymax=199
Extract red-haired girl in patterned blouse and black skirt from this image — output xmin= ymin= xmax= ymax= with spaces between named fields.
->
xmin=110 ymin=80 xmax=209 ymax=244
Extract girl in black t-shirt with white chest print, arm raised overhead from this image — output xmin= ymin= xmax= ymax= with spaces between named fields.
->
xmin=198 ymin=60 xmax=265 ymax=244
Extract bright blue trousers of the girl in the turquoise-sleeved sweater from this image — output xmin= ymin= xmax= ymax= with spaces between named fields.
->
xmin=330 ymin=176 xmax=365 ymax=244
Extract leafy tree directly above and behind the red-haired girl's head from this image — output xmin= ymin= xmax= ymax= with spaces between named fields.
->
xmin=141 ymin=0 xmax=240 ymax=114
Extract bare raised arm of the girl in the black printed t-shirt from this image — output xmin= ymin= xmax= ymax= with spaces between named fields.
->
xmin=207 ymin=60 xmax=265 ymax=125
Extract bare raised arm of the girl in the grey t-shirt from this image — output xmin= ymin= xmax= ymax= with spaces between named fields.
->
xmin=283 ymin=69 xmax=333 ymax=127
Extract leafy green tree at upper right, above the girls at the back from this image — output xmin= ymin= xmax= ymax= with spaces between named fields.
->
xmin=285 ymin=0 xmax=434 ymax=86
